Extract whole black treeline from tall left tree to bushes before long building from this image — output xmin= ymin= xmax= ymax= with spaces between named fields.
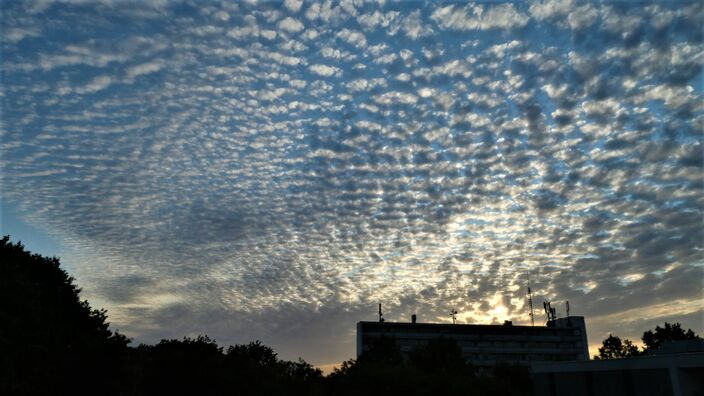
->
xmin=0 ymin=236 xmax=532 ymax=396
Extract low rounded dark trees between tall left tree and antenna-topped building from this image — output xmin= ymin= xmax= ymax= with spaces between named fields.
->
xmin=134 ymin=336 xmax=322 ymax=395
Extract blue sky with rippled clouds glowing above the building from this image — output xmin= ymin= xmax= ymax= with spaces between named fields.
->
xmin=0 ymin=0 xmax=704 ymax=365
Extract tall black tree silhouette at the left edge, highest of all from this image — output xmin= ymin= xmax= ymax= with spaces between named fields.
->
xmin=0 ymin=236 xmax=129 ymax=394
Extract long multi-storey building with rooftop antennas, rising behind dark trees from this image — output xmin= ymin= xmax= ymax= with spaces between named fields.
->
xmin=357 ymin=316 xmax=589 ymax=367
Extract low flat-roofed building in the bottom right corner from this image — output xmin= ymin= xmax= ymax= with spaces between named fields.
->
xmin=532 ymin=344 xmax=704 ymax=396
